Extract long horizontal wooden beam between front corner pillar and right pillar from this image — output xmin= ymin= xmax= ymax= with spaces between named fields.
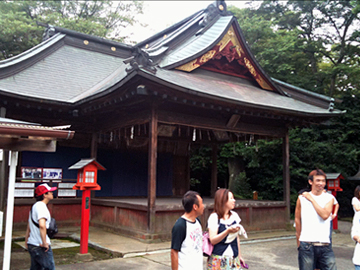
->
xmin=159 ymin=111 xmax=286 ymax=138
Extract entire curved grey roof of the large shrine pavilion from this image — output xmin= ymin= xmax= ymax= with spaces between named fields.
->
xmin=0 ymin=2 xmax=337 ymax=116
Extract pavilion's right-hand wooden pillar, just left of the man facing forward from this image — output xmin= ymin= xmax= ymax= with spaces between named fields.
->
xmin=282 ymin=130 xmax=290 ymax=222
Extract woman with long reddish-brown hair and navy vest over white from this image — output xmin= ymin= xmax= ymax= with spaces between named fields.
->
xmin=207 ymin=188 xmax=245 ymax=270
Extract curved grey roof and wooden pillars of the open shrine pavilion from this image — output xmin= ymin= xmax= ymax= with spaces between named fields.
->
xmin=0 ymin=1 xmax=341 ymax=239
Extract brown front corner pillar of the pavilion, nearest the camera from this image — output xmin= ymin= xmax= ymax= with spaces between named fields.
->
xmin=147 ymin=106 xmax=158 ymax=233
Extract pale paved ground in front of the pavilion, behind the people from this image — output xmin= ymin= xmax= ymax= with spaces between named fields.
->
xmin=4 ymin=222 xmax=354 ymax=270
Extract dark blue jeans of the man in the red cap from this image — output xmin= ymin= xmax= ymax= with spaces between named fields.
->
xmin=28 ymin=244 xmax=55 ymax=270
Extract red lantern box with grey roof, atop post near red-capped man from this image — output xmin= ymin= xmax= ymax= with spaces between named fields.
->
xmin=69 ymin=158 xmax=105 ymax=190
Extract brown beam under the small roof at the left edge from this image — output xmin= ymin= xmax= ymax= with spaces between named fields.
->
xmin=0 ymin=137 xmax=56 ymax=152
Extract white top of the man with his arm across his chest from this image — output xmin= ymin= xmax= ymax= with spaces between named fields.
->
xmin=299 ymin=192 xmax=332 ymax=243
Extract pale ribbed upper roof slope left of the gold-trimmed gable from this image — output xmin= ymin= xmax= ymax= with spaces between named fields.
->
xmin=159 ymin=16 xmax=233 ymax=68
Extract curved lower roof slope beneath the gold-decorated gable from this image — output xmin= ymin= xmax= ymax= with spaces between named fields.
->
xmin=139 ymin=67 xmax=344 ymax=117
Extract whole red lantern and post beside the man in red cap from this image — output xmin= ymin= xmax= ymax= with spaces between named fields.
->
xmin=69 ymin=158 xmax=105 ymax=254
